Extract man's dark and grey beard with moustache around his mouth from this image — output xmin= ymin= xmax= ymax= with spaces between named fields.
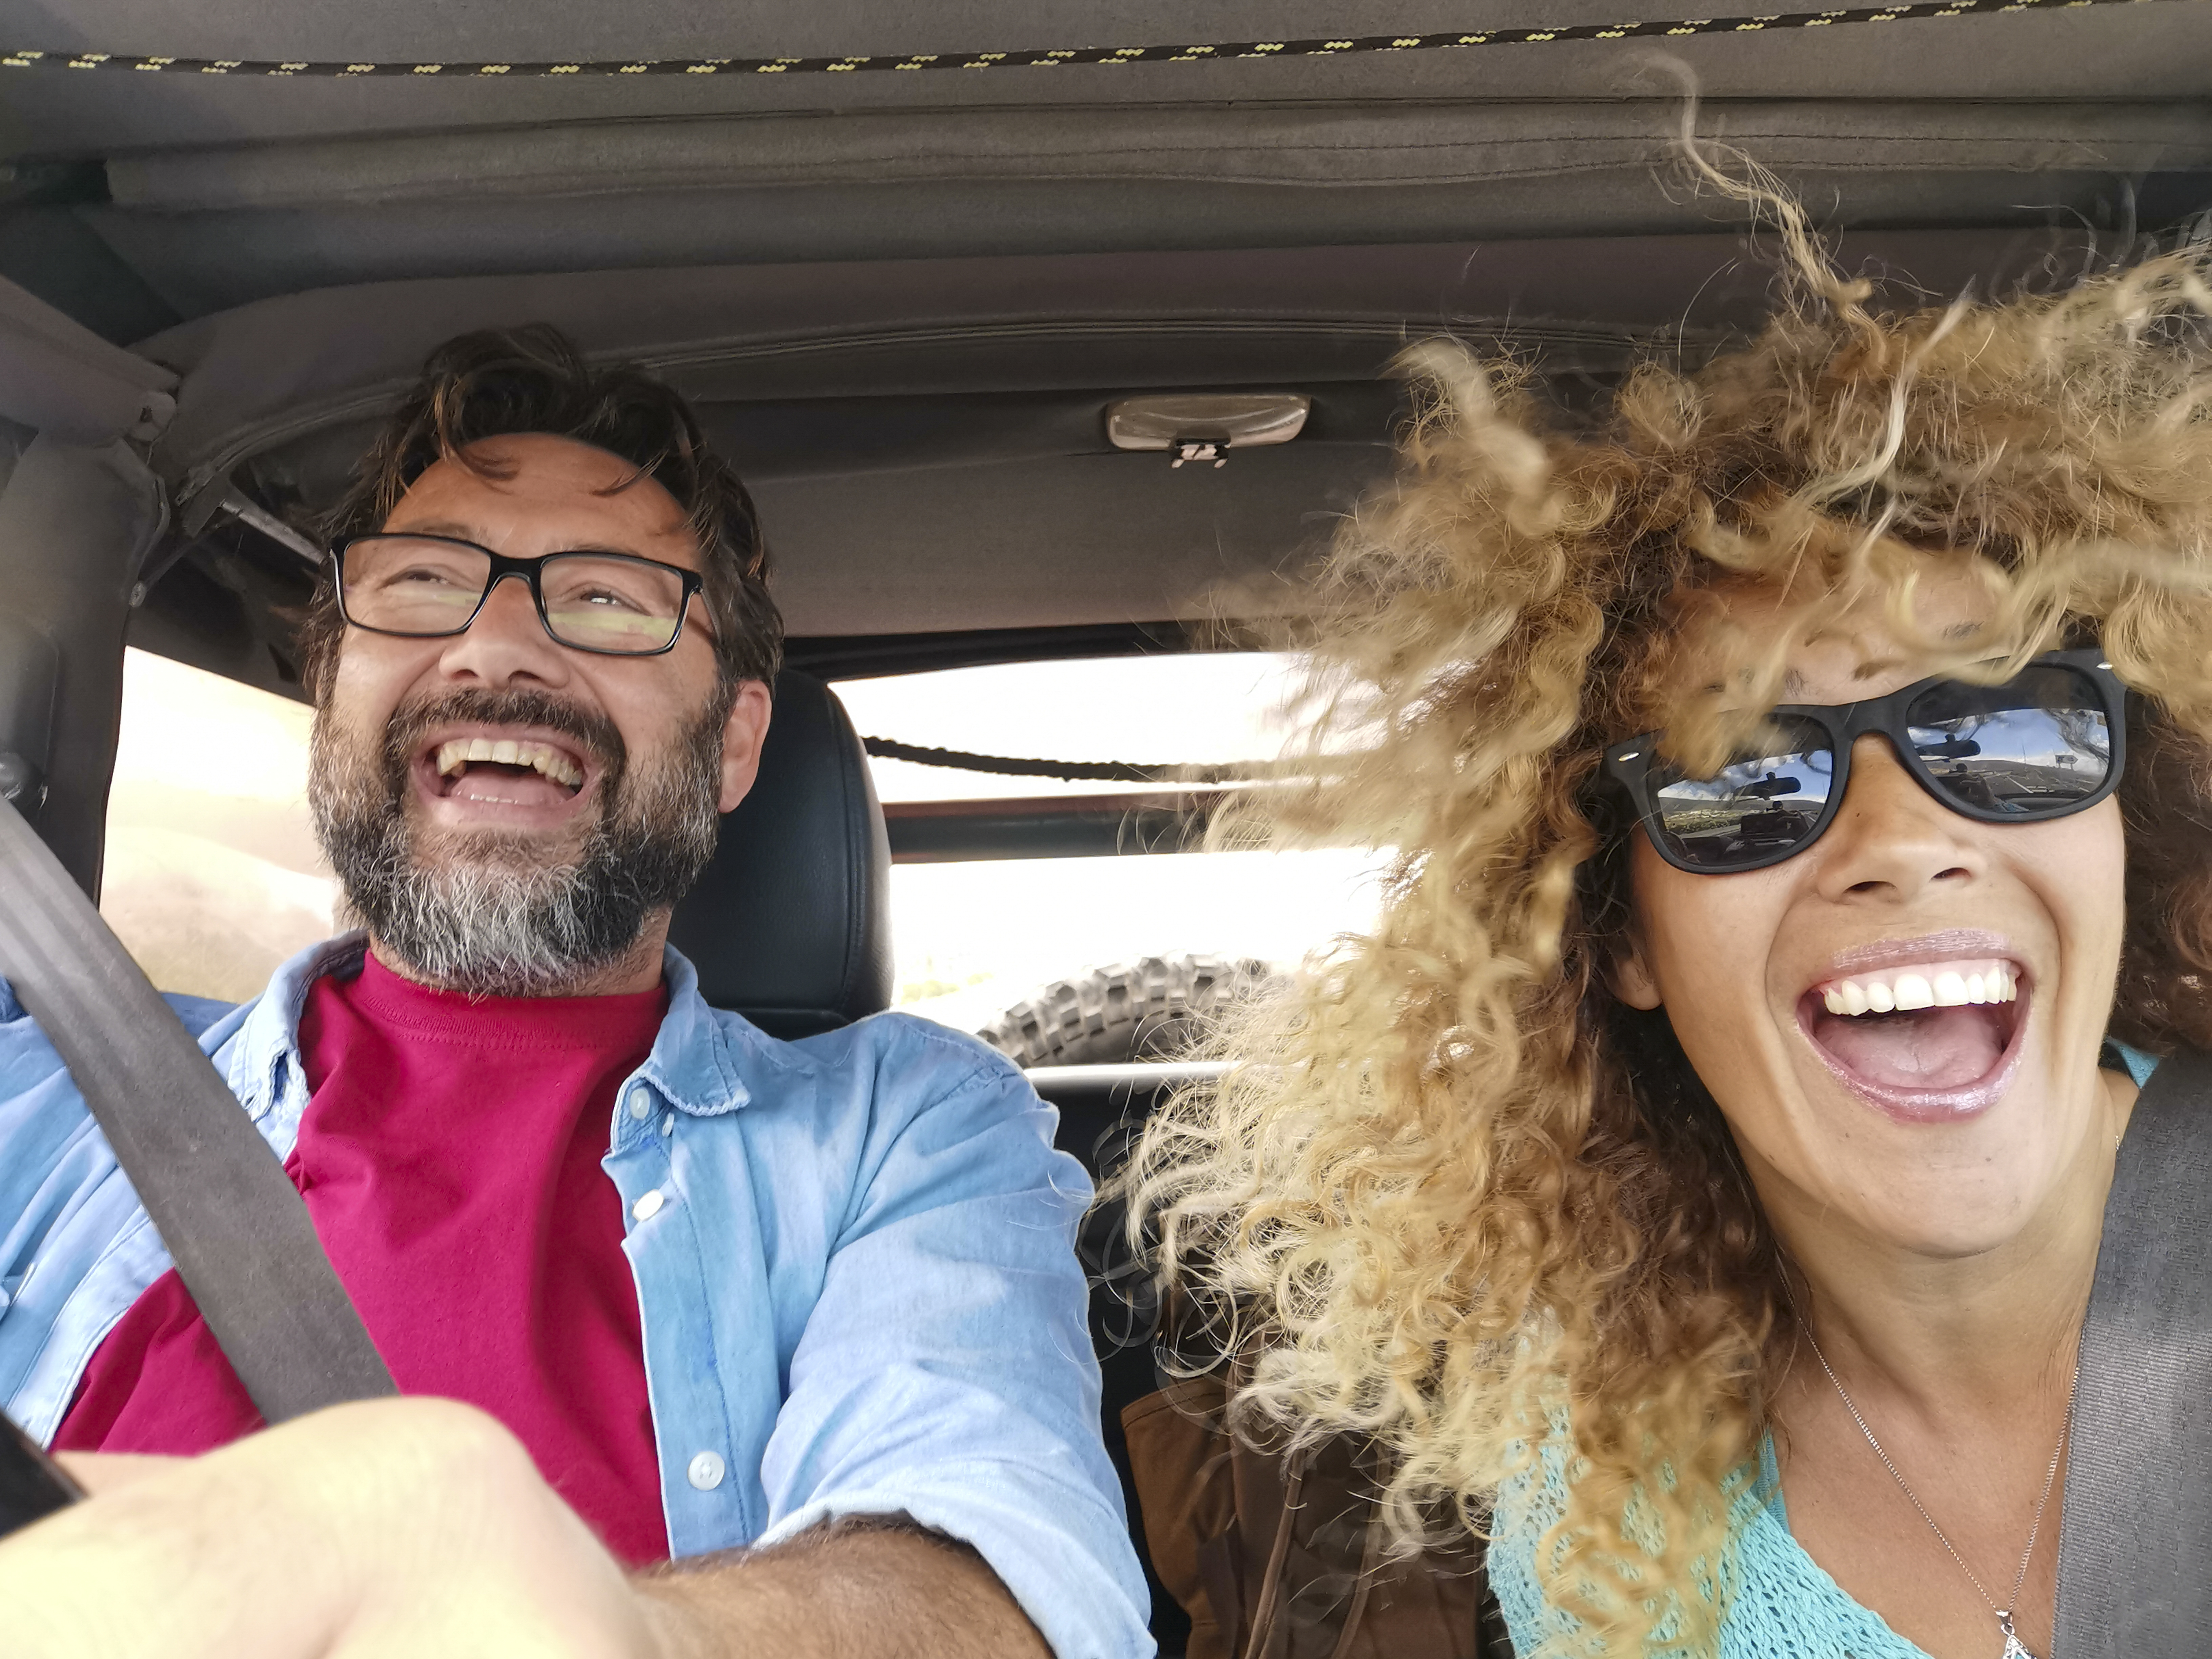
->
xmin=307 ymin=690 xmax=730 ymax=996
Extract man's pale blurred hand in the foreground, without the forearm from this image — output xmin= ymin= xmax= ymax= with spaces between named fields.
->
xmin=0 ymin=1400 xmax=661 ymax=1659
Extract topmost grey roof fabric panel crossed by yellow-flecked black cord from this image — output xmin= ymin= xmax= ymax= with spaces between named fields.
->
xmin=0 ymin=0 xmax=2203 ymax=155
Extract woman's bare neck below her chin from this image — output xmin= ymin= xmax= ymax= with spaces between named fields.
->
xmin=1752 ymin=1073 xmax=2135 ymax=1420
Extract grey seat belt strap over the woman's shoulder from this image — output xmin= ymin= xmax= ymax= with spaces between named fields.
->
xmin=2055 ymin=1051 xmax=2212 ymax=1659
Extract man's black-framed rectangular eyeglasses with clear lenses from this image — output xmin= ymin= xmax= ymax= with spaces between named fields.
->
xmin=330 ymin=531 xmax=703 ymax=657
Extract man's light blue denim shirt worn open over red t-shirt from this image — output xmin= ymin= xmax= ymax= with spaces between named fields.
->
xmin=0 ymin=936 xmax=1152 ymax=1659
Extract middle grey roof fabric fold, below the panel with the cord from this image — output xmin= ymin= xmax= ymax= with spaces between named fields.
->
xmin=106 ymin=100 xmax=2212 ymax=212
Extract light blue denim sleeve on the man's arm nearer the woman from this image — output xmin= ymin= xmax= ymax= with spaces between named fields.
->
xmin=759 ymin=1053 xmax=1152 ymax=1659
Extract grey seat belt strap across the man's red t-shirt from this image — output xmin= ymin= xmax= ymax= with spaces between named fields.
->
xmin=0 ymin=799 xmax=398 ymax=1422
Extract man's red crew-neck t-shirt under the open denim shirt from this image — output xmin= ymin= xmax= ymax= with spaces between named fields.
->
xmin=55 ymin=958 xmax=668 ymax=1564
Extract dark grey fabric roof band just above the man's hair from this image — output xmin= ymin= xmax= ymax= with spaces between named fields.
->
xmin=139 ymin=230 xmax=2097 ymax=489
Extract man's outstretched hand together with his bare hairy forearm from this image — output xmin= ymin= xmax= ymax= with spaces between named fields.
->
xmin=0 ymin=1400 xmax=1048 ymax=1659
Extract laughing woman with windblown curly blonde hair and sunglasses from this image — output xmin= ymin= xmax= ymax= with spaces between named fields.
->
xmin=1130 ymin=214 xmax=2212 ymax=1659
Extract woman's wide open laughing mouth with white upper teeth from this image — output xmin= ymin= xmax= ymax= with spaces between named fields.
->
xmin=1798 ymin=958 xmax=2031 ymax=1124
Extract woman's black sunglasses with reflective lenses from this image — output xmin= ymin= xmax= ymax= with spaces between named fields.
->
xmin=1606 ymin=650 xmax=2128 ymax=876
